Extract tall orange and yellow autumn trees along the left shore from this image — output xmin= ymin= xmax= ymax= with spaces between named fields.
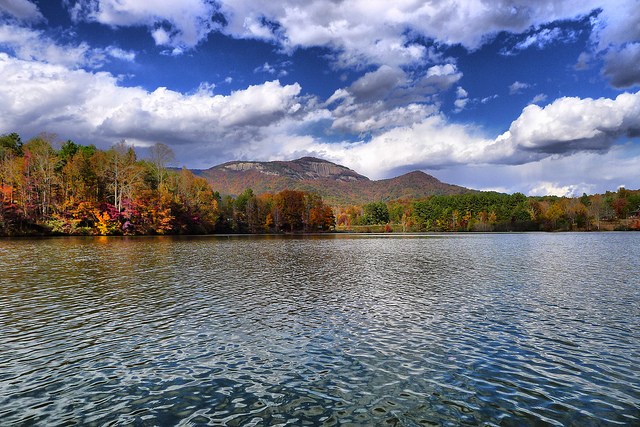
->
xmin=0 ymin=133 xmax=335 ymax=235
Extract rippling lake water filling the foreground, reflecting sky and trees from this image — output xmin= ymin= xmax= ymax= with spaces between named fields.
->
xmin=0 ymin=233 xmax=640 ymax=426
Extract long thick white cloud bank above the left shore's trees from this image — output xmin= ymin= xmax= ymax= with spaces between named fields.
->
xmin=0 ymin=53 xmax=301 ymax=162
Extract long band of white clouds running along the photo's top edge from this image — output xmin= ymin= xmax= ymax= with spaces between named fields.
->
xmin=61 ymin=0 xmax=599 ymax=67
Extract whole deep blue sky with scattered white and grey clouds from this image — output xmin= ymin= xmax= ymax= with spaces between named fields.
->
xmin=0 ymin=0 xmax=640 ymax=196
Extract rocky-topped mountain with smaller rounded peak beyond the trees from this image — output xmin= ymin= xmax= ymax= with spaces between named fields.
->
xmin=197 ymin=157 xmax=474 ymax=205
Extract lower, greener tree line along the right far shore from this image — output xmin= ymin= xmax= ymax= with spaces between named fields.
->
xmin=336 ymin=188 xmax=640 ymax=232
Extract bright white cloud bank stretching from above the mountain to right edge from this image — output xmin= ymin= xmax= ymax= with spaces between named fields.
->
xmin=281 ymin=92 xmax=640 ymax=181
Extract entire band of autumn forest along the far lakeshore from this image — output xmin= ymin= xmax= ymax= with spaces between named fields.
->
xmin=0 ymin=133 xmax=640 ymax=236
